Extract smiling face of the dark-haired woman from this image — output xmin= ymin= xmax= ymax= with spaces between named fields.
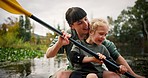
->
xmin=71 ymin=17 xmax=89 ymax=37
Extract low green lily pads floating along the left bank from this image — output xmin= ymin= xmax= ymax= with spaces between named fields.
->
xmin=0 ymin=48 xmax=43 ymax=62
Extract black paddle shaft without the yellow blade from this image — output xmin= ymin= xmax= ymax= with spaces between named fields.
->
xmin=30 ymin=15 xmax=135 ymax=78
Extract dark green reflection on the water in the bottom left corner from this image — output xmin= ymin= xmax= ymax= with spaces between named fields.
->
xmin=0 ymin=61 xmax=31 ymax=78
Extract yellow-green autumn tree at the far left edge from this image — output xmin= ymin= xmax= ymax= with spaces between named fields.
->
xmin=0 ymin=17 xmax=19 ymax=47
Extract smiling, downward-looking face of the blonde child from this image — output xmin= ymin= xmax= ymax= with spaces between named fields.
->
xmin=90 ymin=26 xmax=109 ymax=45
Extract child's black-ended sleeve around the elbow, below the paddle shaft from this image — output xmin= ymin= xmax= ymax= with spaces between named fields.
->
xmin=69 ymin=45 xmax=85 ymax=64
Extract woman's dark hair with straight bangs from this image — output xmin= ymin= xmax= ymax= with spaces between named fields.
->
xmin=66 ymin=7 xmax=87 ymax=25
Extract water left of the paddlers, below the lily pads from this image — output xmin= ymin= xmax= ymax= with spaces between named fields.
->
xmin=0 ymin=54 xmax=66 ymax=78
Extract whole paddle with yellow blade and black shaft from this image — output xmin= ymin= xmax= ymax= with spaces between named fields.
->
xmin=0 ymin=0 xmax=135 ymax=78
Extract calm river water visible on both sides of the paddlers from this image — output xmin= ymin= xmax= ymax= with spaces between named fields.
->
xmin=0 ymin=48 xmax=148 ymax=78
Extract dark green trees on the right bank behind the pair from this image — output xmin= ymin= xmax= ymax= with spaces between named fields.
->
xmin=107 ymin=0 xmax=148 ymax=44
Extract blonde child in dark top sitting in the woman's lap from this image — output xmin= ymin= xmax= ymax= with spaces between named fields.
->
xmin=68 ymin=19 xmax=127 ymax=78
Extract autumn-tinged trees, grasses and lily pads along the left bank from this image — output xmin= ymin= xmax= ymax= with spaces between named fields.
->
xmin=0 ymin=16 xmax=55 ymax=61
